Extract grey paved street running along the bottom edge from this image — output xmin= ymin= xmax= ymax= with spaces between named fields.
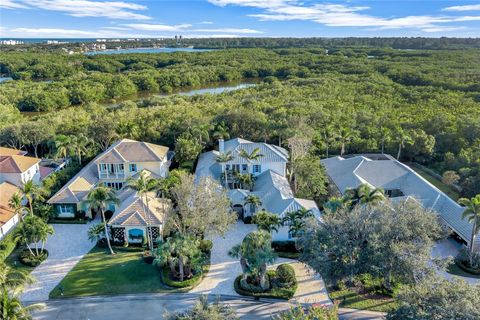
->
xmin=33 ymin=293 xmax=384 ymax=320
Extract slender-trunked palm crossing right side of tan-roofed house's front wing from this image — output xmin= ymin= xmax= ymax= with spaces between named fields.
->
xmin=126 ymin=171 xmax=158 ymax=253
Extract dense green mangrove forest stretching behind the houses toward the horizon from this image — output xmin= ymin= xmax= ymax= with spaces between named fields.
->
xmin=0 ymin=47 xmax=480 ymax=200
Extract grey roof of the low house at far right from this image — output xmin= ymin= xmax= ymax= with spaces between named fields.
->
xmin=321 ymin=155 xmax=480 ymax=245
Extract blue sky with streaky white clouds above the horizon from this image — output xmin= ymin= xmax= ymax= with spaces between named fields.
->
xmin=0 ymin=0 xmax=480 ymax=38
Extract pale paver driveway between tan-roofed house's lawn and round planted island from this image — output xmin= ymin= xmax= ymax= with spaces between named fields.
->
xmin=190 ymin=221 xmax=257 ymax=296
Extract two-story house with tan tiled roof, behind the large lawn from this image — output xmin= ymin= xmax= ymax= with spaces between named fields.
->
xmin=48 ymin=139 xmax=170 ymax=244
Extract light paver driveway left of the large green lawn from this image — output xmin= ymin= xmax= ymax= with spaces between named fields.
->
xmin=22 ymin=222 xmax=95 ymax=301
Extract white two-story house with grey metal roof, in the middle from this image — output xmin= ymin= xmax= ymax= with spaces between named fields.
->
xmin=195 ymin=138 xmax=320 ymax=240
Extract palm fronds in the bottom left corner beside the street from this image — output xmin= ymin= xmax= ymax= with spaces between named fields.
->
xmin=0 ymin=287 xmax=45 ymax=320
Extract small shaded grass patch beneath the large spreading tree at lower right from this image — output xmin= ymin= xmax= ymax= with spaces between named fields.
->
xmin=328 ymin=289 xmax=397 ymax=312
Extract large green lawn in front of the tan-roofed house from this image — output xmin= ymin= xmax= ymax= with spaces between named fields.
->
xmin=50 ymin=247 xmax=181 ymax=298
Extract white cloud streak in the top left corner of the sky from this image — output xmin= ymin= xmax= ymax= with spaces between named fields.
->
xmin=1 ymin=0 xmax=151 ymax=20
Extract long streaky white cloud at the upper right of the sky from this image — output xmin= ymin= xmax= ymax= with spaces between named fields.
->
xmin=209 ymin=0 xmax=480 ymax=32
